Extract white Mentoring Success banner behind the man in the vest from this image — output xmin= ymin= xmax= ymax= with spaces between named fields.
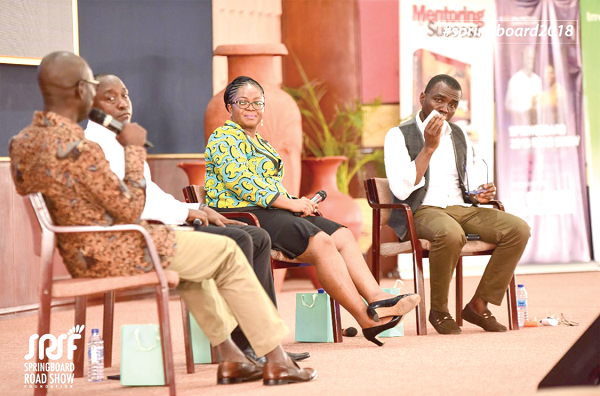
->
xmin=400 ymin=0 xmax=495 ymax=176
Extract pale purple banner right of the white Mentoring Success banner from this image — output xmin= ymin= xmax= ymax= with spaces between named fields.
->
xmin=495 ymin=0 xmax=597 ymax=263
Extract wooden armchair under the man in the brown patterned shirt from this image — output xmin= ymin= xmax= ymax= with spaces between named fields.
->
xmin=25 ymin=193 xmax=179 ymax=395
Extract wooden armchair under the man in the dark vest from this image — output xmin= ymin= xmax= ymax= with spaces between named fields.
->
xmin=365 ymin=178 xmax=519 ymax=335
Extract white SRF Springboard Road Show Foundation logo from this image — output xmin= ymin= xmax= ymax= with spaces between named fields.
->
xmin=24 ymin=325 xmax=85 ymax=388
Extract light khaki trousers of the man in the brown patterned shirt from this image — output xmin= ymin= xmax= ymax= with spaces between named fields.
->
xmin=169 ymin=231 xmax=289 ymax=356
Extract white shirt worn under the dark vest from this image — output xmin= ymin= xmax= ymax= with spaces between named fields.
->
xmin=384 ymin=111 xmax=481 ymax=208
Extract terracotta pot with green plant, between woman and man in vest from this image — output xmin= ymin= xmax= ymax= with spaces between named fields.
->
xmin=302 ymin=156 xmax=362 ymax=241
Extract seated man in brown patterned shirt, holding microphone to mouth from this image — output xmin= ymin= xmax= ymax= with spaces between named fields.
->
xmin=9 ymin=52 xmax=316 ymax=384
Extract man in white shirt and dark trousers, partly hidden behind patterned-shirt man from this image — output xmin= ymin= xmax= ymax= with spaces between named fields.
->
xmin=85 ymin=74 xmax=310 ymax=361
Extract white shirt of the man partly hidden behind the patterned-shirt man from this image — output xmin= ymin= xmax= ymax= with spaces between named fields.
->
xmin=85 ymin=121 xmax=200 ymax=224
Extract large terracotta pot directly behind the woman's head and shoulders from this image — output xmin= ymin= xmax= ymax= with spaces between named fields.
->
xmin=204 ymin=44 xmax=302 ymax=195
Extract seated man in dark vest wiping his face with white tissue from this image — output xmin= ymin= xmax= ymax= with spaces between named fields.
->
xmin=384 ymin=74 xmax=530 ymax=334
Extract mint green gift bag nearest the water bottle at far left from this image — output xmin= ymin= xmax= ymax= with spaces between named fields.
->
xmin=121 ymin=324 xmax=165 ymax=386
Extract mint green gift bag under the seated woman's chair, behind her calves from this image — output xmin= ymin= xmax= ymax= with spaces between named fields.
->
xmin=296 ymin=293 xmax=333 ymax=342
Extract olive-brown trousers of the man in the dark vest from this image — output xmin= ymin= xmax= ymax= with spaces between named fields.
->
xmin=414 ymin=205 xmax=531 ymax=312
